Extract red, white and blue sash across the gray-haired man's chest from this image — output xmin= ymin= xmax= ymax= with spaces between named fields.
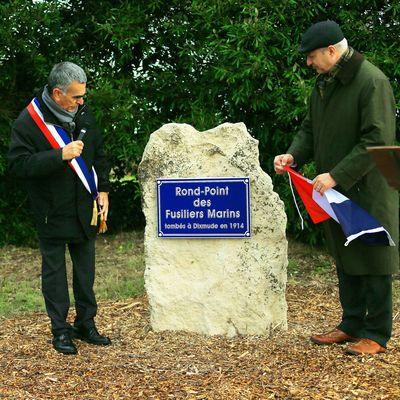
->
xmin=27 ymin=97 xmax=98 ymax=200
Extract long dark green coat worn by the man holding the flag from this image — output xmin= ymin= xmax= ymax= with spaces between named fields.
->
xmin=287 ymin=51 xmax=399 ymax=275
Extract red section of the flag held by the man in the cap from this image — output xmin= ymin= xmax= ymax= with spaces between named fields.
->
xmin=284 ymin=166 xmax=331 ymax=224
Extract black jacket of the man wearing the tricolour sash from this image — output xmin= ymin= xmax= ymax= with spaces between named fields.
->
xmin=8 ymin=90 xmax=109 ymax=241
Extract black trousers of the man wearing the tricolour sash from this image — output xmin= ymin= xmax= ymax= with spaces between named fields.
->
xmin=39 ymin=239 xmax=97 ymax=335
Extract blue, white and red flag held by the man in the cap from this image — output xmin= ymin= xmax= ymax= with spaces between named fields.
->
xmin=285 ymin=166 xmax=395 ymax=246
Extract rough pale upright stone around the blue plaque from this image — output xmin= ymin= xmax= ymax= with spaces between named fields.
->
xmin=139 ymin=123 xmax=287 ymax=337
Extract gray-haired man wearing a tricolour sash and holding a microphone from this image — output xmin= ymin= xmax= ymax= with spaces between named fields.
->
xmin=8 ymin=62 xmax=111 ymax=354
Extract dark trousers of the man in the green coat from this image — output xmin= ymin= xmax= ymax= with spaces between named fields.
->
xmin=337 ymin=268 xmax=393 ymax=347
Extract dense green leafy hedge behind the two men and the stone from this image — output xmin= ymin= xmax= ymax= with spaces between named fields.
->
xmin=0 ymin=0 xmax=400 ymax=244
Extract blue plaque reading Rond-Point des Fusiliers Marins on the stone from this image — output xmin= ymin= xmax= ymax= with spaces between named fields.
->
xmin=157 ymin=178 xmax=250 ymax=238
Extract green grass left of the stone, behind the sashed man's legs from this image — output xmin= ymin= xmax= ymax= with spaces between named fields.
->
xmin=0 ymin=232 xmax=144 ymax=317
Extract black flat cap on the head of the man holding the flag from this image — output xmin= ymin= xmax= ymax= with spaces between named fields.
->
xmin=299 ymin=20 xmax=344 ymax=53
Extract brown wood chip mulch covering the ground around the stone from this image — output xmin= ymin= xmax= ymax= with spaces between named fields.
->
xmin=0 ymin=282 xmax=400 ymax=400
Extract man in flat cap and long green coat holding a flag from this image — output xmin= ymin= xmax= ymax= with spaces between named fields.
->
xmin=274 ymin=21 xmax=399 ymax=354
